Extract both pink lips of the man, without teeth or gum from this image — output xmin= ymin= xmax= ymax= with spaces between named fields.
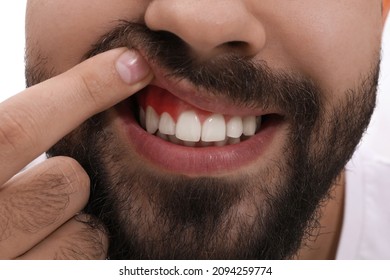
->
xmin=111 ymin=56 xmax=282 ymax=176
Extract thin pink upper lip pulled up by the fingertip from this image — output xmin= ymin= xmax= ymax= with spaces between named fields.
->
xmin=139 ymin=52 xmax=282 ymax=116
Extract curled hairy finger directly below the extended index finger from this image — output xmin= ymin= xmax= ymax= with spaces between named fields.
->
xmin=0 ymin=157 xmax=88 ymax=235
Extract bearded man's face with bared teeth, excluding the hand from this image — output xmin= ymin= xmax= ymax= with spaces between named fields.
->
xmin=27 ymin=0 xmax=382 ymax=259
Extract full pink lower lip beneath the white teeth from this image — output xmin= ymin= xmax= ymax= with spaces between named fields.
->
xmin=116 ymin=101 xmax=280 ymax=176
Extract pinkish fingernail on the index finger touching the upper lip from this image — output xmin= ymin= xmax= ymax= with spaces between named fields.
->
xmin=116 ymin=50 xmax=150 ymax=84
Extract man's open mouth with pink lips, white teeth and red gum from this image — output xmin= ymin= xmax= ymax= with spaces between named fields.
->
xmin=116 ymin=67 xmax=284 ymax=176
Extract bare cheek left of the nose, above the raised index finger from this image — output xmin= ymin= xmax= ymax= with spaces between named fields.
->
xmin=26 ymin=0 xmax=147 ymax=74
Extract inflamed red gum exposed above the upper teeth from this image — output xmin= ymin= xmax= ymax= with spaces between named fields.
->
xmin=138 ymin=85 xmax=212 ymax=123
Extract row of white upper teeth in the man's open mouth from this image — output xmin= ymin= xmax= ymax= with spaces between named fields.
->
xmin=140 ymin=106 xmax=261 ymax=146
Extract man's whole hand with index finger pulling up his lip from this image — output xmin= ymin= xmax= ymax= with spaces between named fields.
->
xmin=0 ymin=48 xmax=152 ymax=259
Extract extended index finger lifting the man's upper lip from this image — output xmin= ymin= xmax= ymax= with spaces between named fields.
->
xmin=0 ymin=48 xmax=152 ymax=185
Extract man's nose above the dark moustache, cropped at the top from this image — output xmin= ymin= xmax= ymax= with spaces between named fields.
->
xmin=145 ymin=0 xmax=266 ymax=57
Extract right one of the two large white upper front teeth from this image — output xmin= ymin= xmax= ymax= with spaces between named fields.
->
xmin=202 ymin=114 xmax=226 ymax=142
